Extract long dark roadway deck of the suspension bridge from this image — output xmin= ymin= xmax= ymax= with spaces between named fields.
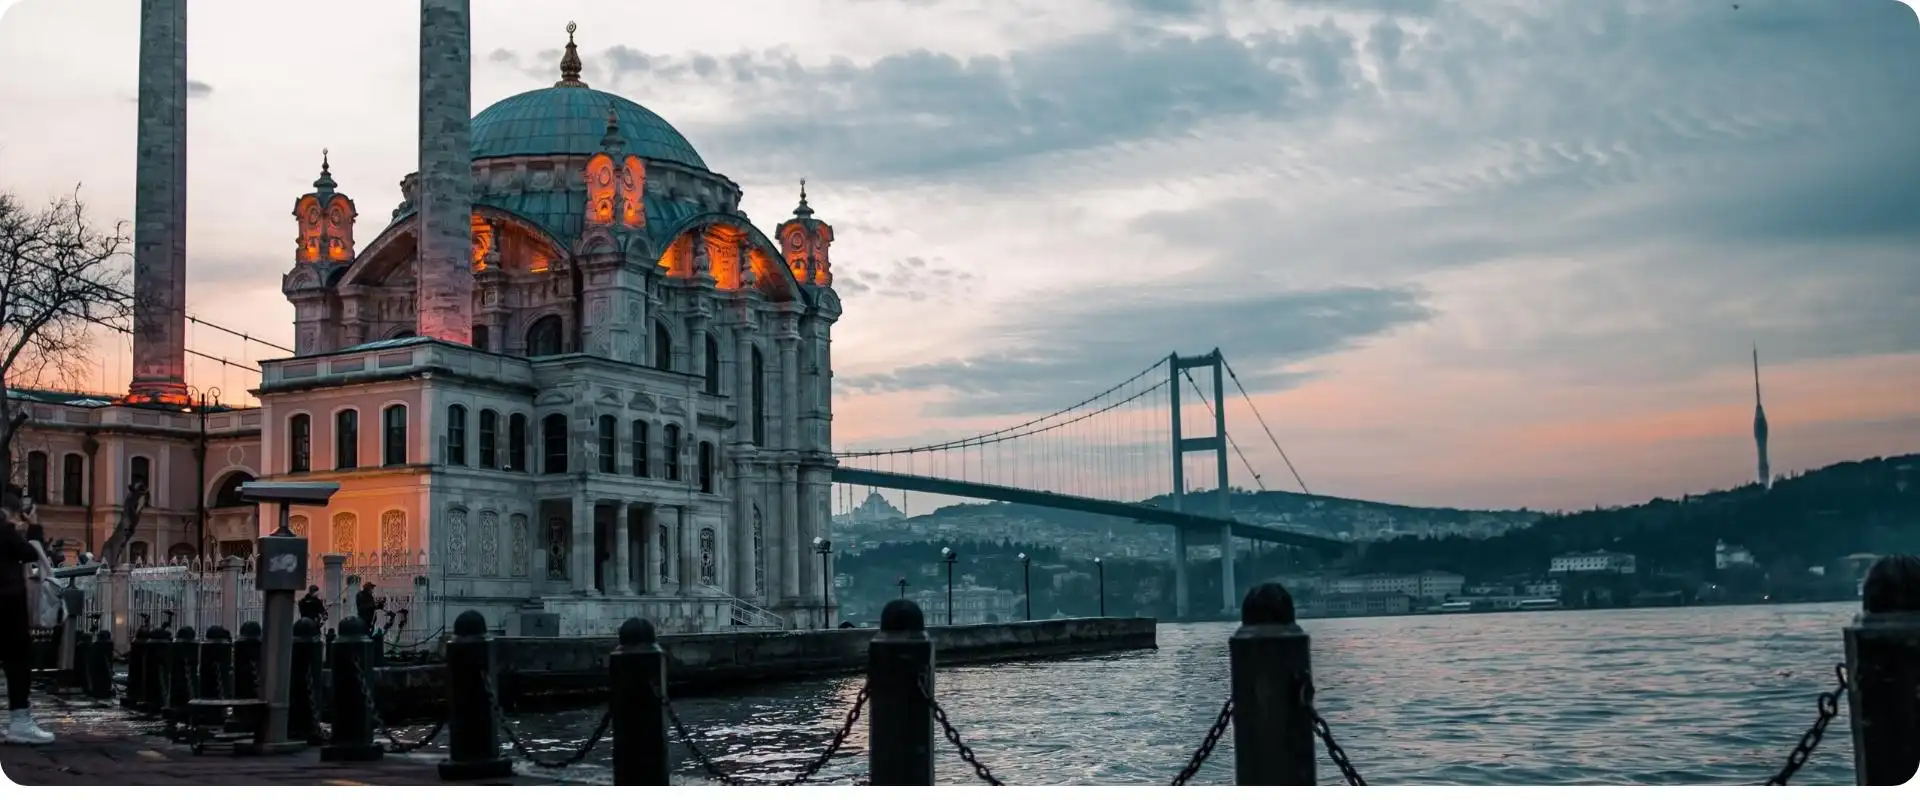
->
xmin=833 ymin=466 xmax=1346 ymax=554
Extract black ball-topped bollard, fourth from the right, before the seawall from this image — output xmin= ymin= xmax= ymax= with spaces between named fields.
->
xmin=607 ymin=618 xmax=672 ymax=787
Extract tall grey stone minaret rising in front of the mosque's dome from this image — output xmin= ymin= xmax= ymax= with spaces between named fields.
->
xmin=415 ymin=0 xmax=474 ymax=345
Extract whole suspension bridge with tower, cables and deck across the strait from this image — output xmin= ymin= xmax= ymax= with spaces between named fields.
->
xmin=833 ymin=349 xmax=1348 ymax=618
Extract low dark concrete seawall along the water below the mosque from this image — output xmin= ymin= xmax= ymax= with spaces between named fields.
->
xmin=376 ymin=618 xmax=1158 ymax=718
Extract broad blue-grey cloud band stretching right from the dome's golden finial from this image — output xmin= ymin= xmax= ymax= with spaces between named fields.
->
xmin=541 ymin=25 xmax=1361 ymax=178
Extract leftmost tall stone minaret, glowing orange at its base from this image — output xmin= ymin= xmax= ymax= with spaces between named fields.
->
xmin=127 ymin=0 xmax=188 ymax=405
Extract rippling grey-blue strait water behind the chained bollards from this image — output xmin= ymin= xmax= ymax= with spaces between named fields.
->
xmin=382 ymin=602 xmax=1859 ymax=785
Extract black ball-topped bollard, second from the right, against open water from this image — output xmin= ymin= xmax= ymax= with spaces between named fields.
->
xmin=1227 ymin=583 xmax=1313 ymax=787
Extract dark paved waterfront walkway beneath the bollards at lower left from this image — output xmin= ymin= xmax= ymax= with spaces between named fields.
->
xmin=0 ymin=693 xmax=561 ymax=787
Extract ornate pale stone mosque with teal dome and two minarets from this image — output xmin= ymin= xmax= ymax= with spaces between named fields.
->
xmin=5 ymin=0 xmax=841 ymax=635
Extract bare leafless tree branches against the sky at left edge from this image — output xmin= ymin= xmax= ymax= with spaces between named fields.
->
xmin=0 ymin=188 xmax=132 ymax=480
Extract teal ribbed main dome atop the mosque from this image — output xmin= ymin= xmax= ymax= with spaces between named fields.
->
xmin=472 ymin=86 xmax=707 ymax=169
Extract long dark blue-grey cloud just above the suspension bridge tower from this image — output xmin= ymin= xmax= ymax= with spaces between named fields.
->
xmin=835 ymin=286 xmax=1432 ymax=416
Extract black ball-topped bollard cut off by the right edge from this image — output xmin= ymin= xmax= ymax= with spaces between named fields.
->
xmin=1845 ymin=556 xmax=1920 ymax=787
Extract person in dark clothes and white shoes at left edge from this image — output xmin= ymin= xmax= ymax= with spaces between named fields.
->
xmin=0 ymin=485 xmax=54 ymax=744
